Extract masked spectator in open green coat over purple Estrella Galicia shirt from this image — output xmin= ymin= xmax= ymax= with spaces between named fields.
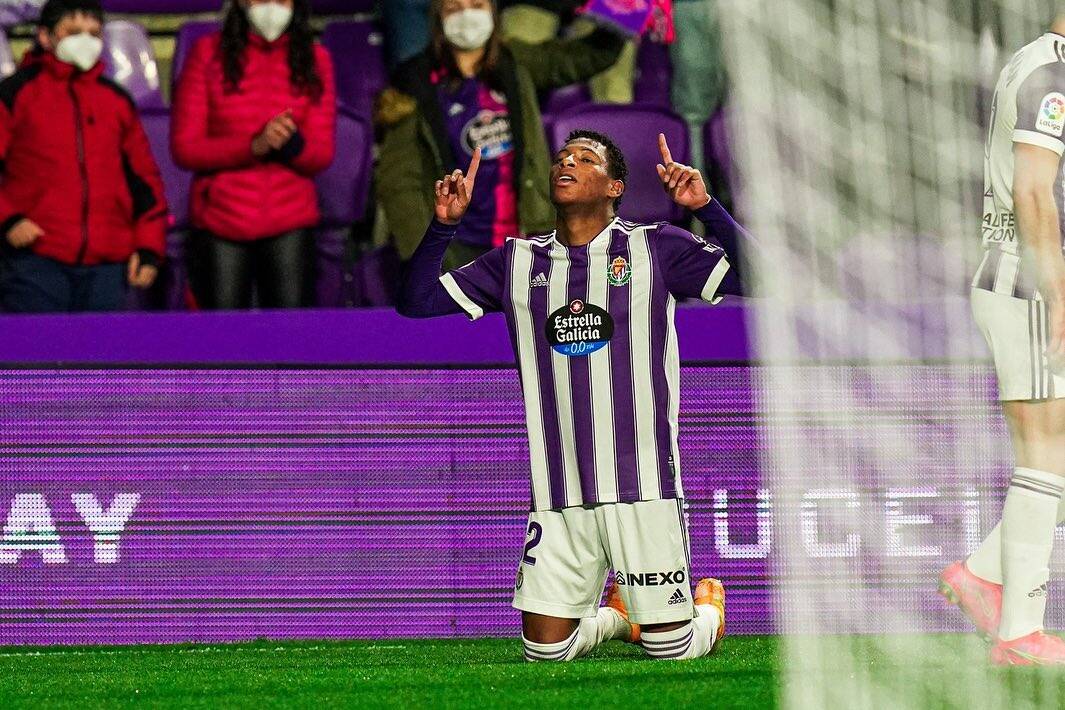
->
xmin=377 ymin=0 xmax=623 ymax=268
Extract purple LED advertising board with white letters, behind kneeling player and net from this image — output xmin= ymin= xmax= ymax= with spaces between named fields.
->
xmin=0 ymin=364 xmax=1039 ymax=645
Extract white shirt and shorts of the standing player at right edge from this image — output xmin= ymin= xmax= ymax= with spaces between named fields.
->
xmin=972 ymin=32 xmax=1065 ymax=400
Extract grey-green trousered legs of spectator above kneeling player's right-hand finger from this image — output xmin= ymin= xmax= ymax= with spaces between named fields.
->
xmin=670 ymin=0 xmax=728 ymax=174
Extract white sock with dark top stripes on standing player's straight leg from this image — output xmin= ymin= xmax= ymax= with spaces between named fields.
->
xmin=999 ymin=468 xmax=1065 ymax=641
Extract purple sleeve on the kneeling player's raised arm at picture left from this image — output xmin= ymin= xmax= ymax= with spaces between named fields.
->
xmin=396 ymin=219 xmax=503 ymax=320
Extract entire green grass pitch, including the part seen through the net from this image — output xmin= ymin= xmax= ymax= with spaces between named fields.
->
xmin=0 ymin=634 xmax=1065 ymax=710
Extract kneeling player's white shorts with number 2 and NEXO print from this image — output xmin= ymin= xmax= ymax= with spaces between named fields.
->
xmin=514 ymin=499 xmax=694 ymax=624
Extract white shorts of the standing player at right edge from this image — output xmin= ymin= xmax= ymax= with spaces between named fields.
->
xmin=972 ymin=288 xmax=1065 ymax=401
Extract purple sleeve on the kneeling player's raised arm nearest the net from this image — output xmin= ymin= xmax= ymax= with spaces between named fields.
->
xmin=655 ymin=200 xmax=743 ymax=303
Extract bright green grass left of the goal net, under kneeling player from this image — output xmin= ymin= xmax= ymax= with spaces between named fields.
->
xmin=0 ymin=637 xmax=776 ymax=710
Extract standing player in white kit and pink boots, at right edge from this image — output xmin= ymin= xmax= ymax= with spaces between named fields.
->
xmin=939 ymin=15 xmax=1065 ymax=665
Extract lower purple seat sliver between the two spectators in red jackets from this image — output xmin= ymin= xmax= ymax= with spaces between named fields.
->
xmin=141 ymin=109 xmax=193 ymax=311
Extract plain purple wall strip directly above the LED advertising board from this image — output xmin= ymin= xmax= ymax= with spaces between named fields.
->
xmin=0 ymin=298 xmax=750 ymax=365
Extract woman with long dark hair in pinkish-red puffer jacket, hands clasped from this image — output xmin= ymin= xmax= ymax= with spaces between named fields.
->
xmin=170 ymin=0 xmax=334 ymax=309
